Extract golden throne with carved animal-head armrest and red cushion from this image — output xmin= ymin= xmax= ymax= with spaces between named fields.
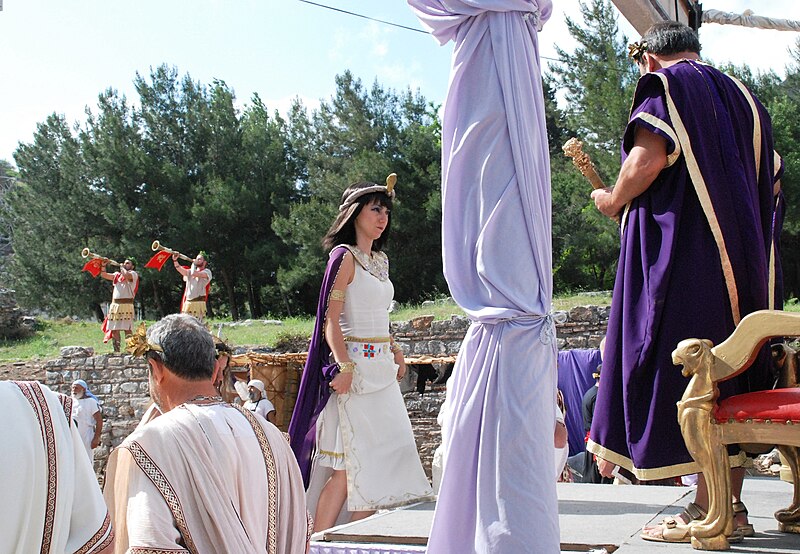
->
xmin=672 ymin=310 xmax=800 ymax=550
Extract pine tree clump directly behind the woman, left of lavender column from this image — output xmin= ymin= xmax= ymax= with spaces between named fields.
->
xmin=274 ymin=72 xmax=446 ymax=312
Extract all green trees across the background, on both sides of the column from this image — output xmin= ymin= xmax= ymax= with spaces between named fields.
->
xmin=0 ymin=10 xmax=800 ymax=319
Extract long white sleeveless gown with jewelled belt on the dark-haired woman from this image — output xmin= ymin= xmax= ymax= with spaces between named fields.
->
xmin=308 ymin=249 xmax=433 ymax=521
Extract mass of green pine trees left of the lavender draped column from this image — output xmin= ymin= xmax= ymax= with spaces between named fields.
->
xmin=4 ymin=66 xmax=444 ymax=319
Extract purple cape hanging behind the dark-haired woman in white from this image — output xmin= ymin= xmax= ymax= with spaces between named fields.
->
xmin=289 ymin=248 xmax=347 ymax=488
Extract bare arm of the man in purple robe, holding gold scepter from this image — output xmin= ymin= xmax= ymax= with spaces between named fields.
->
xmin=592 ymin=127 xmax=667 ymax=217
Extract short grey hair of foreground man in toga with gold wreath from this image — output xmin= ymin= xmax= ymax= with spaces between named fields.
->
xmin=147 ymin=314 xmax=216 ymax=381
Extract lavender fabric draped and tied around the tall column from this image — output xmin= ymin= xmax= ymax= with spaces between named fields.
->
xmin=408 ymin=0 xmax=559 ymax=554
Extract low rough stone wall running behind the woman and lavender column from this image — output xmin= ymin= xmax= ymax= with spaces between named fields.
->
xmin=43 ymin=306 xmax=608 ymax=478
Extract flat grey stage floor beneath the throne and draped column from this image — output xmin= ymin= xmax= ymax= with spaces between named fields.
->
xmin=311 ymin=477 xmax=800 ymax=554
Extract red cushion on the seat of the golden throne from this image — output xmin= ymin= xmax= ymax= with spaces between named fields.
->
xmin=714 ymin=388 xmax=800 ymax=424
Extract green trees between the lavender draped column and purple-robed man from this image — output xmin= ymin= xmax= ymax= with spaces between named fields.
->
xmin=545 ymin=0 xmax=638 ymax=292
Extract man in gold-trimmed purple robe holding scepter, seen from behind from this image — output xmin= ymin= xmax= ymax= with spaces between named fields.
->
xmin=587 ymin=22 xmax=782 ymax=542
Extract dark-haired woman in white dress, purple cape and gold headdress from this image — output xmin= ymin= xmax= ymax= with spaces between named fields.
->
xmin=289 ymin=174 xmax=433 ymax=531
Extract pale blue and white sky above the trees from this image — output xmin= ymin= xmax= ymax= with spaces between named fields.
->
xmin=0 ymin=0 xmax=800 ymax=162
